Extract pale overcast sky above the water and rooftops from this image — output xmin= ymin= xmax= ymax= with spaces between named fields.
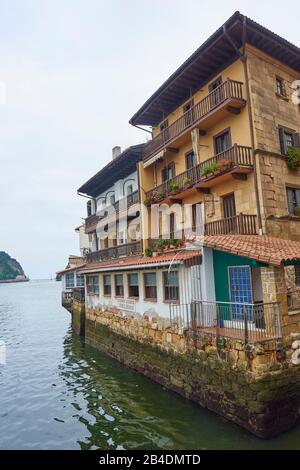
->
xmin=0 ymin=0 xmax=299 ymax=278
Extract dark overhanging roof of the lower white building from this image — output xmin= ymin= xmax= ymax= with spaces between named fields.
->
xmin=77 ymin=144 xmax=145 ymax=197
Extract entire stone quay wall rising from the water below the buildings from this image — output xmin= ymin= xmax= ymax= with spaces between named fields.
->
xmin=85 ymin=309 xmax=300 ymax=438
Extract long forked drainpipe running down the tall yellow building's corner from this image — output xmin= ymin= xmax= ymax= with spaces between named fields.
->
xmin=223 ymin=16 xmax=263 ymax=235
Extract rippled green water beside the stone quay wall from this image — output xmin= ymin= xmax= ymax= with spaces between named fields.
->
xmin=0 ymin=282 xmax=300 ymax=450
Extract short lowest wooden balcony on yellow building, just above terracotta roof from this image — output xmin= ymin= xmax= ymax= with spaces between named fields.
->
xmin=204 ymin=214 xmax=258 ymax=235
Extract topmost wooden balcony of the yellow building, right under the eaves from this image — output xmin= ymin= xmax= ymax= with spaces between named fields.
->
xmin=143 ymin=80 xmax=246 ymax=160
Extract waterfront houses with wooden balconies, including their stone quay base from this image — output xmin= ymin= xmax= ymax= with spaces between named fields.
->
xmin=58 ymin=12 xmax=300 ymax=437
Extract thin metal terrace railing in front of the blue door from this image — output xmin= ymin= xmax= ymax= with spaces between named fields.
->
xmin=170 ymin=300 xmax=282 ymax=342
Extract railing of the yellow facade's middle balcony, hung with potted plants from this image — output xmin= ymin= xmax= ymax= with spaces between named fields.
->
xmin=145 ymin=144 xmax=253 ymax=204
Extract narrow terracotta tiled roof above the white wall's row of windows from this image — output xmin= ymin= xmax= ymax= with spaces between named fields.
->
xmin=84 ymin=250 xmax=201 ymax=272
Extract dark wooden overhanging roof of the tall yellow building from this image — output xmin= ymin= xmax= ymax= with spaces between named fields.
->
xmin=130 ymin=11 xmax=300 ymax=126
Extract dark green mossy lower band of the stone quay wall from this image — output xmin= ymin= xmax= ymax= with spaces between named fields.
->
xmin=86 ymin=312 xmax=300 ymax=437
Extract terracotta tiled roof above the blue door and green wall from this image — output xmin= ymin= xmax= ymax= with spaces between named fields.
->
xmin=203 ymin=235 xmax=300 ymax=266
